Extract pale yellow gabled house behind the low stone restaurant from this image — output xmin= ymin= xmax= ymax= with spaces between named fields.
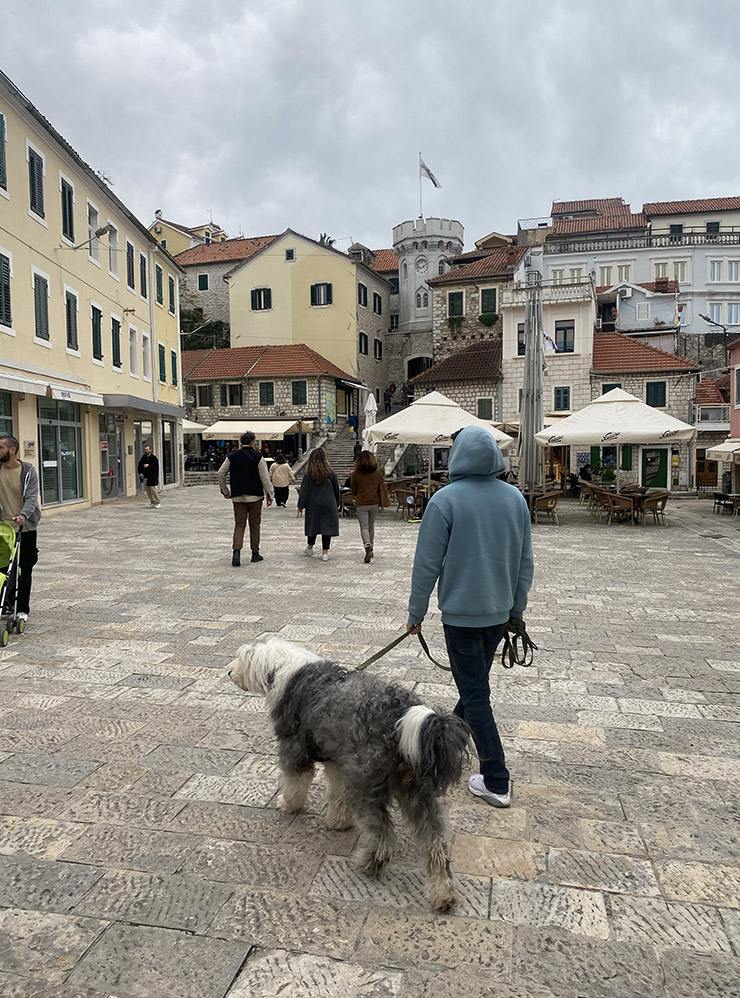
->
xmin=226 ymin=229 xmax=390 ymax=414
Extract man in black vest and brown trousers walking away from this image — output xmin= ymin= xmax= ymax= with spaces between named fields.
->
xmin=218 ymin=431 xmax=273 ymax=568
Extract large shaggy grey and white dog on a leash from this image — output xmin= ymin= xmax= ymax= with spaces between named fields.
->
xmin=229 ymin=637 xmax=470 ymax=911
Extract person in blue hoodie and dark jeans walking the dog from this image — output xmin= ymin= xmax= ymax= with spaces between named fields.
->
xmin=407 ymin=426 xmax=534 ymax=807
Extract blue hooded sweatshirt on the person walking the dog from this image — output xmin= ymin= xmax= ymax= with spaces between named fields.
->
xmin=409 ymin=426 xmax=534 ymax=627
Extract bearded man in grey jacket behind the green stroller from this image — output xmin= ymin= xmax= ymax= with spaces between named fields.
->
xmin=0 ymin=437 xmax=41 ymax=621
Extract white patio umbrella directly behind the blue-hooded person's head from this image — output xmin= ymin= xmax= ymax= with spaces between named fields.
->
xmin=362 ymin=392 xmax=514 ymax=488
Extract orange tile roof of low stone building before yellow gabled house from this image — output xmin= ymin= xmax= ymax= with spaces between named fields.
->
xmin=188 ymin=343 xmax=357 ymax=381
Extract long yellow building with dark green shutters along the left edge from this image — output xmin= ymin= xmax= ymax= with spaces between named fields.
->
xmin=0 ymin=73 xmax=184 ymax=509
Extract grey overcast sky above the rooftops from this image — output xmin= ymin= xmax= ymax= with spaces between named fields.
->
xmin=0 ymin=0 xmax=740 ymax=249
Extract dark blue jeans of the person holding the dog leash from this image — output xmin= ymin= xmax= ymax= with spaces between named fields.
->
xmin=443 ymin=624 xmax=509 ymax=794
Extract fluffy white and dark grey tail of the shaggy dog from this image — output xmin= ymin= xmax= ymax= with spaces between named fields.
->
xmin=396 ymin=704 xmax=470 ymax=790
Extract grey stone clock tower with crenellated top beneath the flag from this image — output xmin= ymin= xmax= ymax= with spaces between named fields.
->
xmin=389 ymin=218 xmax=465 ymax=383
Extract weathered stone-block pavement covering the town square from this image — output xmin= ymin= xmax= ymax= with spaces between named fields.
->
xmin=0 ymin=487 xmax=740 ymax=998
